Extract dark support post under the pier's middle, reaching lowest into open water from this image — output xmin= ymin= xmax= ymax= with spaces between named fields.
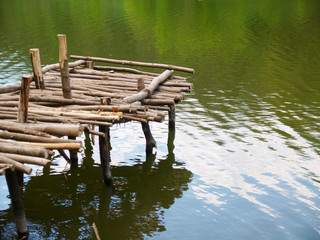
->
xmin=99 ymin=125 xmax=113 ymax=186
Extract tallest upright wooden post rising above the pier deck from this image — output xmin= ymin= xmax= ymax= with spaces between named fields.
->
xmin=58 ymin=34 xmax=72 ymax=99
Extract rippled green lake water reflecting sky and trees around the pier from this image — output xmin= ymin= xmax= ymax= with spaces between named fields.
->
xmin=0 ymin=0 xmax=320 ymax=239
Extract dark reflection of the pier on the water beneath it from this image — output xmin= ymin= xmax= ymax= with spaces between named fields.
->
xmin=0 ymin=130 xmax=192 ymax=239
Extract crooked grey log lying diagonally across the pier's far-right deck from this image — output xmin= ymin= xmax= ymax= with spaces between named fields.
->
xmin=123 ymin=70 xmax=173 ymax=103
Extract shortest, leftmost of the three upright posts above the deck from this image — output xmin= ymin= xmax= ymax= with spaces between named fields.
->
xmin=17 ymin=74 xmax=31 ymax=123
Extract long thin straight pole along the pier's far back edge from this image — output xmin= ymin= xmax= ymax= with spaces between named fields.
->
xmin=70 ymin=55 xmax=195 ymax=73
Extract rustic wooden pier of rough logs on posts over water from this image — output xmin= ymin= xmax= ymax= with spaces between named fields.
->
xmin=0 ymin=34 xmax=194 ymax=237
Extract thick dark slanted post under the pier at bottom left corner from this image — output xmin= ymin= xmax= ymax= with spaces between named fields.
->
xmin=6 ymin=169 xmax=29 ymax=239
